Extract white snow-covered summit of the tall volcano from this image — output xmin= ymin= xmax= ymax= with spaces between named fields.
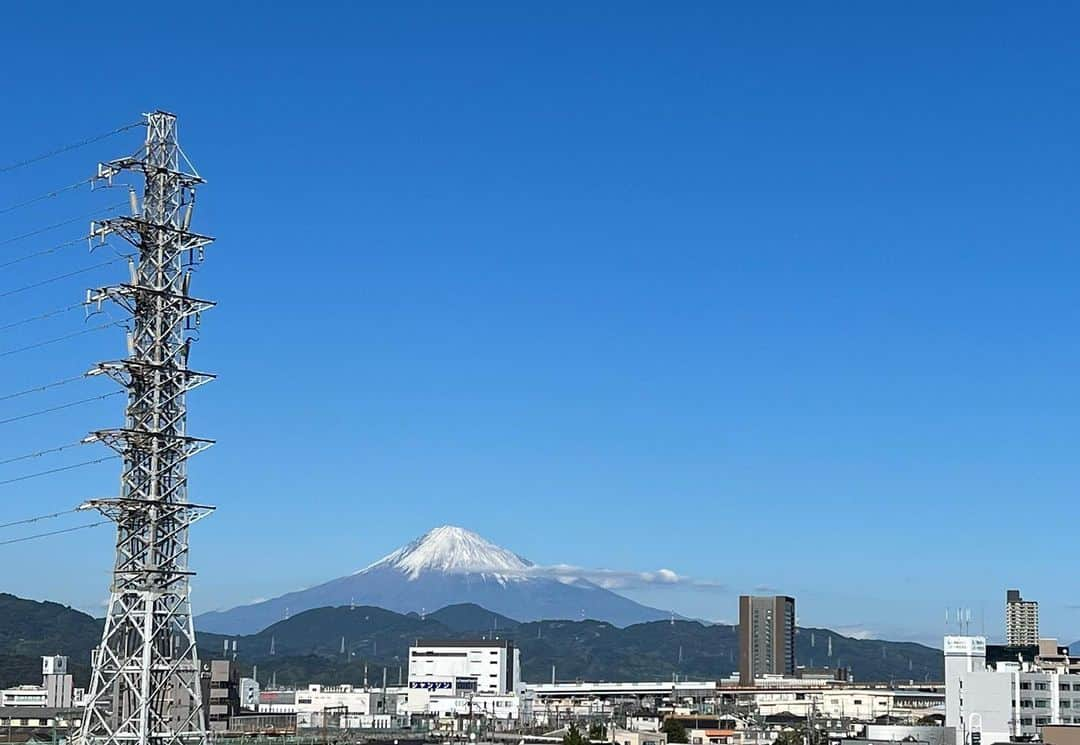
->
xmin=356 ymin=525 xmax=532 ymax=580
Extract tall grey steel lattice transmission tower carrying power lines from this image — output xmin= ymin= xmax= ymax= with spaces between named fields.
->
xmin=81 ymin=111 xmax=214 ymax=745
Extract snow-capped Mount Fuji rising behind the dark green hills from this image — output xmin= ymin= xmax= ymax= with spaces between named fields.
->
xmin=195 ymin=525 xmax=670 ymax=634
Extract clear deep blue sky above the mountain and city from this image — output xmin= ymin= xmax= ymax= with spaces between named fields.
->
xmin=0 ymin=2 xmax=1080 ymax=640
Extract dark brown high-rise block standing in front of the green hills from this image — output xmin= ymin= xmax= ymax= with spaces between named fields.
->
xmin=739 ymin=595 xmax=795 ymax=686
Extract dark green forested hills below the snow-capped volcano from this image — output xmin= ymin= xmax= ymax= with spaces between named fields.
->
xmin=0 ymin=595 xmax=943 ymax=687
